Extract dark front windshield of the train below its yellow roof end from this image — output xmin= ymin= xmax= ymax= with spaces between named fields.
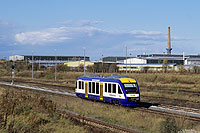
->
xmin=123 ymin=83 xmax=138 ymax=94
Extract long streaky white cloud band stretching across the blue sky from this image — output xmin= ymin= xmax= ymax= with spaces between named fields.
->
xmin=15 ymin=27 xmax=184 ymax=46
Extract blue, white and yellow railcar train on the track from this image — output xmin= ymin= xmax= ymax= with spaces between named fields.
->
xmin=75 ymin=74 xmax=140 ymax=106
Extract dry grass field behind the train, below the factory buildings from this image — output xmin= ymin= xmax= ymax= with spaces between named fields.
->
xmin=1 ymin=71 xmax=200 ymax=108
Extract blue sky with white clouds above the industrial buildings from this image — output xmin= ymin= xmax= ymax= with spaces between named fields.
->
xmin=0 ymin=0 xmax=200 ymax=60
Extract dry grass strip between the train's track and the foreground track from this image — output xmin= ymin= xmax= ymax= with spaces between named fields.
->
xmin=0 ymin=82 xmax=199 ymax=132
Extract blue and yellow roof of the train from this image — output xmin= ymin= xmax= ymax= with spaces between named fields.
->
xmin=78 ymin=74 xmax=136 ymax=83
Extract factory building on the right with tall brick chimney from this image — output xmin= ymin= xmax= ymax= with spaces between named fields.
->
xmin=117 ymin=27 xmax=200 ymax=71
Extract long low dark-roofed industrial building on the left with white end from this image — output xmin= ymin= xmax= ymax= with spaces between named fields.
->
xmin=9 ymin=55 xmax=90 ymax=66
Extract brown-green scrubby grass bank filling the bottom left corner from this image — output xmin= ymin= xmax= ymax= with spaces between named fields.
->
xmin=0 ymin=88 xmax=89 ymax=133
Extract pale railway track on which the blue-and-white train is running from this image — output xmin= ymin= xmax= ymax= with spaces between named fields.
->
xmin=0 ymin=82 xmax=200 ymax=122
